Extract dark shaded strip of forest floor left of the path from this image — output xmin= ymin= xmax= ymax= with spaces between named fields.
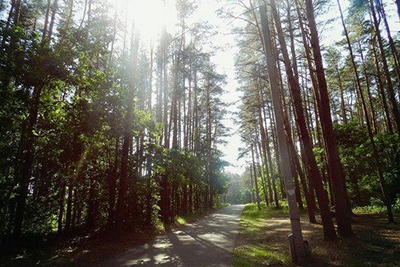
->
xmin=0 ymin=205 xmax=233 ymax=267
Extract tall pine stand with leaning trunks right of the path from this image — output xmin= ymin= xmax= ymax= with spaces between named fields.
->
xmin=226 ymin=0 xmax=400 ymax=243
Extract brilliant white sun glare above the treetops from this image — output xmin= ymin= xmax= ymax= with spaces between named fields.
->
xmin=109 ymin=0 xmax=176 ymax=40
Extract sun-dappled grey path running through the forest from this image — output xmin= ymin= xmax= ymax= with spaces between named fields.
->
xmin=98 ymin=205 xmax=244 ymax=267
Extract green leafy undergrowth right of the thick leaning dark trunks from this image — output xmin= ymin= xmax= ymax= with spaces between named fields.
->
xmin=335 ymin=121 xmax=400 ymax=206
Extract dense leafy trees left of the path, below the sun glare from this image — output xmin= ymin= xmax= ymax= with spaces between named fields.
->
xmin=0 ymin=0 xmax=227 ymax=241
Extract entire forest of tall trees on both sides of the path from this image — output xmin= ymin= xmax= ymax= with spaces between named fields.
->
xmin=0 ymin=0 xmax=400 ymax=264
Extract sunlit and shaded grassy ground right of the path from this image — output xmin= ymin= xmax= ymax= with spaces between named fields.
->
xmin=233 ymin=204 xmax=400 ymax=267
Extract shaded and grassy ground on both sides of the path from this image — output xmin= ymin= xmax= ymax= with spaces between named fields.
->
xmin=0 ymin=205 xmax=400 ymax=267
